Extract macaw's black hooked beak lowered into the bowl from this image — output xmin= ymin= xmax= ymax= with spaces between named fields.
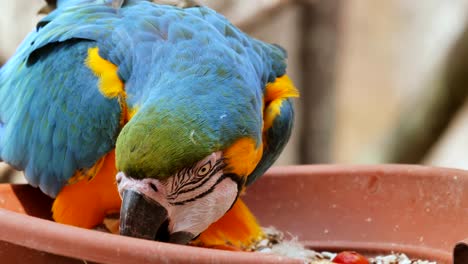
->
xmin=120 ymin=190 xmax=195 ymax=244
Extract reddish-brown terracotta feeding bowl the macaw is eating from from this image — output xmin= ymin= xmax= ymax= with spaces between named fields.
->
xmin=0 ymin=165 xmax=468 ymax=263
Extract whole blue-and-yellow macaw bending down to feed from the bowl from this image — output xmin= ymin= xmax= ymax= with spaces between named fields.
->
xmin=0 ymin=0 xmax=298 ymax=249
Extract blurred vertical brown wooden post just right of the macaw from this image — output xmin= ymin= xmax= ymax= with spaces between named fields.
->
xmin=300 ymin=0 xmax=342 ymax=163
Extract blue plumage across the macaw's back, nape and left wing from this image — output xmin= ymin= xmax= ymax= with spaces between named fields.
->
xmin=0 ymin=0 xmax=289 ymax=196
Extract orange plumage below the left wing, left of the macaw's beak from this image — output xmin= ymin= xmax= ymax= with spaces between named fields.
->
xmin=52 ymin=150 xmax=121 ymax=228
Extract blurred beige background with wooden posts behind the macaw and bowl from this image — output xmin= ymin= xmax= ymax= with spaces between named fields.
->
xmin=0 ymin=0 xmax=468 ymax=184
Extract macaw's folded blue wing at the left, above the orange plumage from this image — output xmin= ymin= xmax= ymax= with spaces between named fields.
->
xmin=0 ymin=40 xmax=121 ymax=196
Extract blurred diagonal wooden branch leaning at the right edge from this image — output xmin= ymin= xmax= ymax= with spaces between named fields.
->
xmin=365 ymin=25 xmax=468 ymax=163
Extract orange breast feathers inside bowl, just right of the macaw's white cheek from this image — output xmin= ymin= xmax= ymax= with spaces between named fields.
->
xmin=192 ymin=199 xmax=264 ymax=250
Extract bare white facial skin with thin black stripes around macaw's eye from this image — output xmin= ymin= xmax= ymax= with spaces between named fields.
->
xmin=117 ymin=152 xmax=238 ymax=235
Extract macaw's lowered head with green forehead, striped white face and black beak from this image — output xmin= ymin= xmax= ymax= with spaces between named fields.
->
xmin=116 ymin=71 xmax=263 ymax=244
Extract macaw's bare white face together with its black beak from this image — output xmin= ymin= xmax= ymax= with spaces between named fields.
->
xmin=117 ymin=152 xmax=239 ymax=244
